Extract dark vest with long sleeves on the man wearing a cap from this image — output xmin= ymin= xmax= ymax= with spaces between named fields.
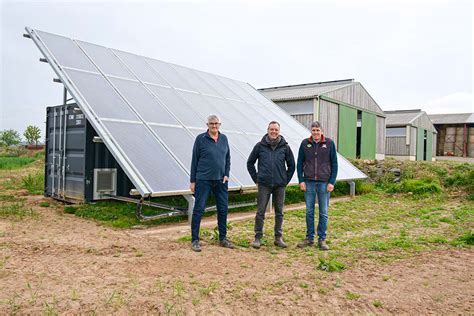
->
xmin=297 ymin=136 xmax=338 ymax=184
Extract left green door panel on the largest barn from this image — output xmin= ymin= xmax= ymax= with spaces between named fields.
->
xmin=337 ymin=105 xmax=357 ymax=158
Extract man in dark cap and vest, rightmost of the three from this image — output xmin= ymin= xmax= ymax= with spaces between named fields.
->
xmin=296 ymin=121 xmax=337 ymax=250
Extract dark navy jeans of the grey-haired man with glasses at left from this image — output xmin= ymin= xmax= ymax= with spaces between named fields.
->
xmin=191 ymin=180 xmax=229 ymax=241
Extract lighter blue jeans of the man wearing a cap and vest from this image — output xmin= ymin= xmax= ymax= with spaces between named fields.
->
xmin=304 ymin=180 xmax=331 ymax=240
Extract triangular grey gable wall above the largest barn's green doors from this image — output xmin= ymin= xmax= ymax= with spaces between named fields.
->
xmin=324 ymin=83 xmax=383 ymax=114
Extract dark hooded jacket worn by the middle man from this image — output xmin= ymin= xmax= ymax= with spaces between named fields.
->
xmin=247 ymin=135 xmax=295 ymax=187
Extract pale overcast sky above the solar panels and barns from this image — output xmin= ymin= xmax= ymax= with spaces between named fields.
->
xmin=0 ymin=0 xmax=474 ymax=137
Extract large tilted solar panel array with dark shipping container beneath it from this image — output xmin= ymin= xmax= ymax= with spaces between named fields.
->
xmin=25 ymin=28 xmax=366 ymax=215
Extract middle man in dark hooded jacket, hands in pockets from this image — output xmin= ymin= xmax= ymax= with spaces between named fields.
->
xmin=247 ymin=121 xmax=295 ymax=248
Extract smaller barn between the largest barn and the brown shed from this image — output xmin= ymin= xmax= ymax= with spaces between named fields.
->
xmin=385 ymin=110 xmax=437 ymax=161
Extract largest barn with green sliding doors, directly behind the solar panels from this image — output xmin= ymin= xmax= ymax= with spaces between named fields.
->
xmin=259 ymin=79 xmax=385 ymax=159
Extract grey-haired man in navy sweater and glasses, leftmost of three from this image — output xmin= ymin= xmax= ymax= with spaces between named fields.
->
xmin=189 ymin=115 xmax=234 ymax=251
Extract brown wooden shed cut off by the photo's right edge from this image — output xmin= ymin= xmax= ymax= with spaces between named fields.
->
xmin=429 ymin=113 xmax=474 ymax=157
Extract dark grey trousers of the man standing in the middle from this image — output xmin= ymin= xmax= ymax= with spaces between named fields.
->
xmin=255 ymin=184 xmax=285 ymax=239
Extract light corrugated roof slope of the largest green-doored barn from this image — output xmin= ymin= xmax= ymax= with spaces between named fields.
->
xmin=259 ymin=79 xmax=355 ymax=101
